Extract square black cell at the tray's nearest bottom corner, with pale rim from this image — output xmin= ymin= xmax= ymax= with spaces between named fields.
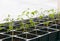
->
xmin=17 ymin=33 xmax=39 ymax=41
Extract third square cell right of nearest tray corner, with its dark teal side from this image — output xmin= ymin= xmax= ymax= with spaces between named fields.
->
xmin=40 ymin=28 xmax=58 ymax=41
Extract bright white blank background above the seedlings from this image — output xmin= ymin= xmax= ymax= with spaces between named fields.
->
xmin=0 ymin=0 xmax=57 ymax=22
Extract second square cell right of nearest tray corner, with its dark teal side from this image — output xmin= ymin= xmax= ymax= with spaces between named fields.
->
xmin=30 ymin=30 xmax=49 ymax=41
